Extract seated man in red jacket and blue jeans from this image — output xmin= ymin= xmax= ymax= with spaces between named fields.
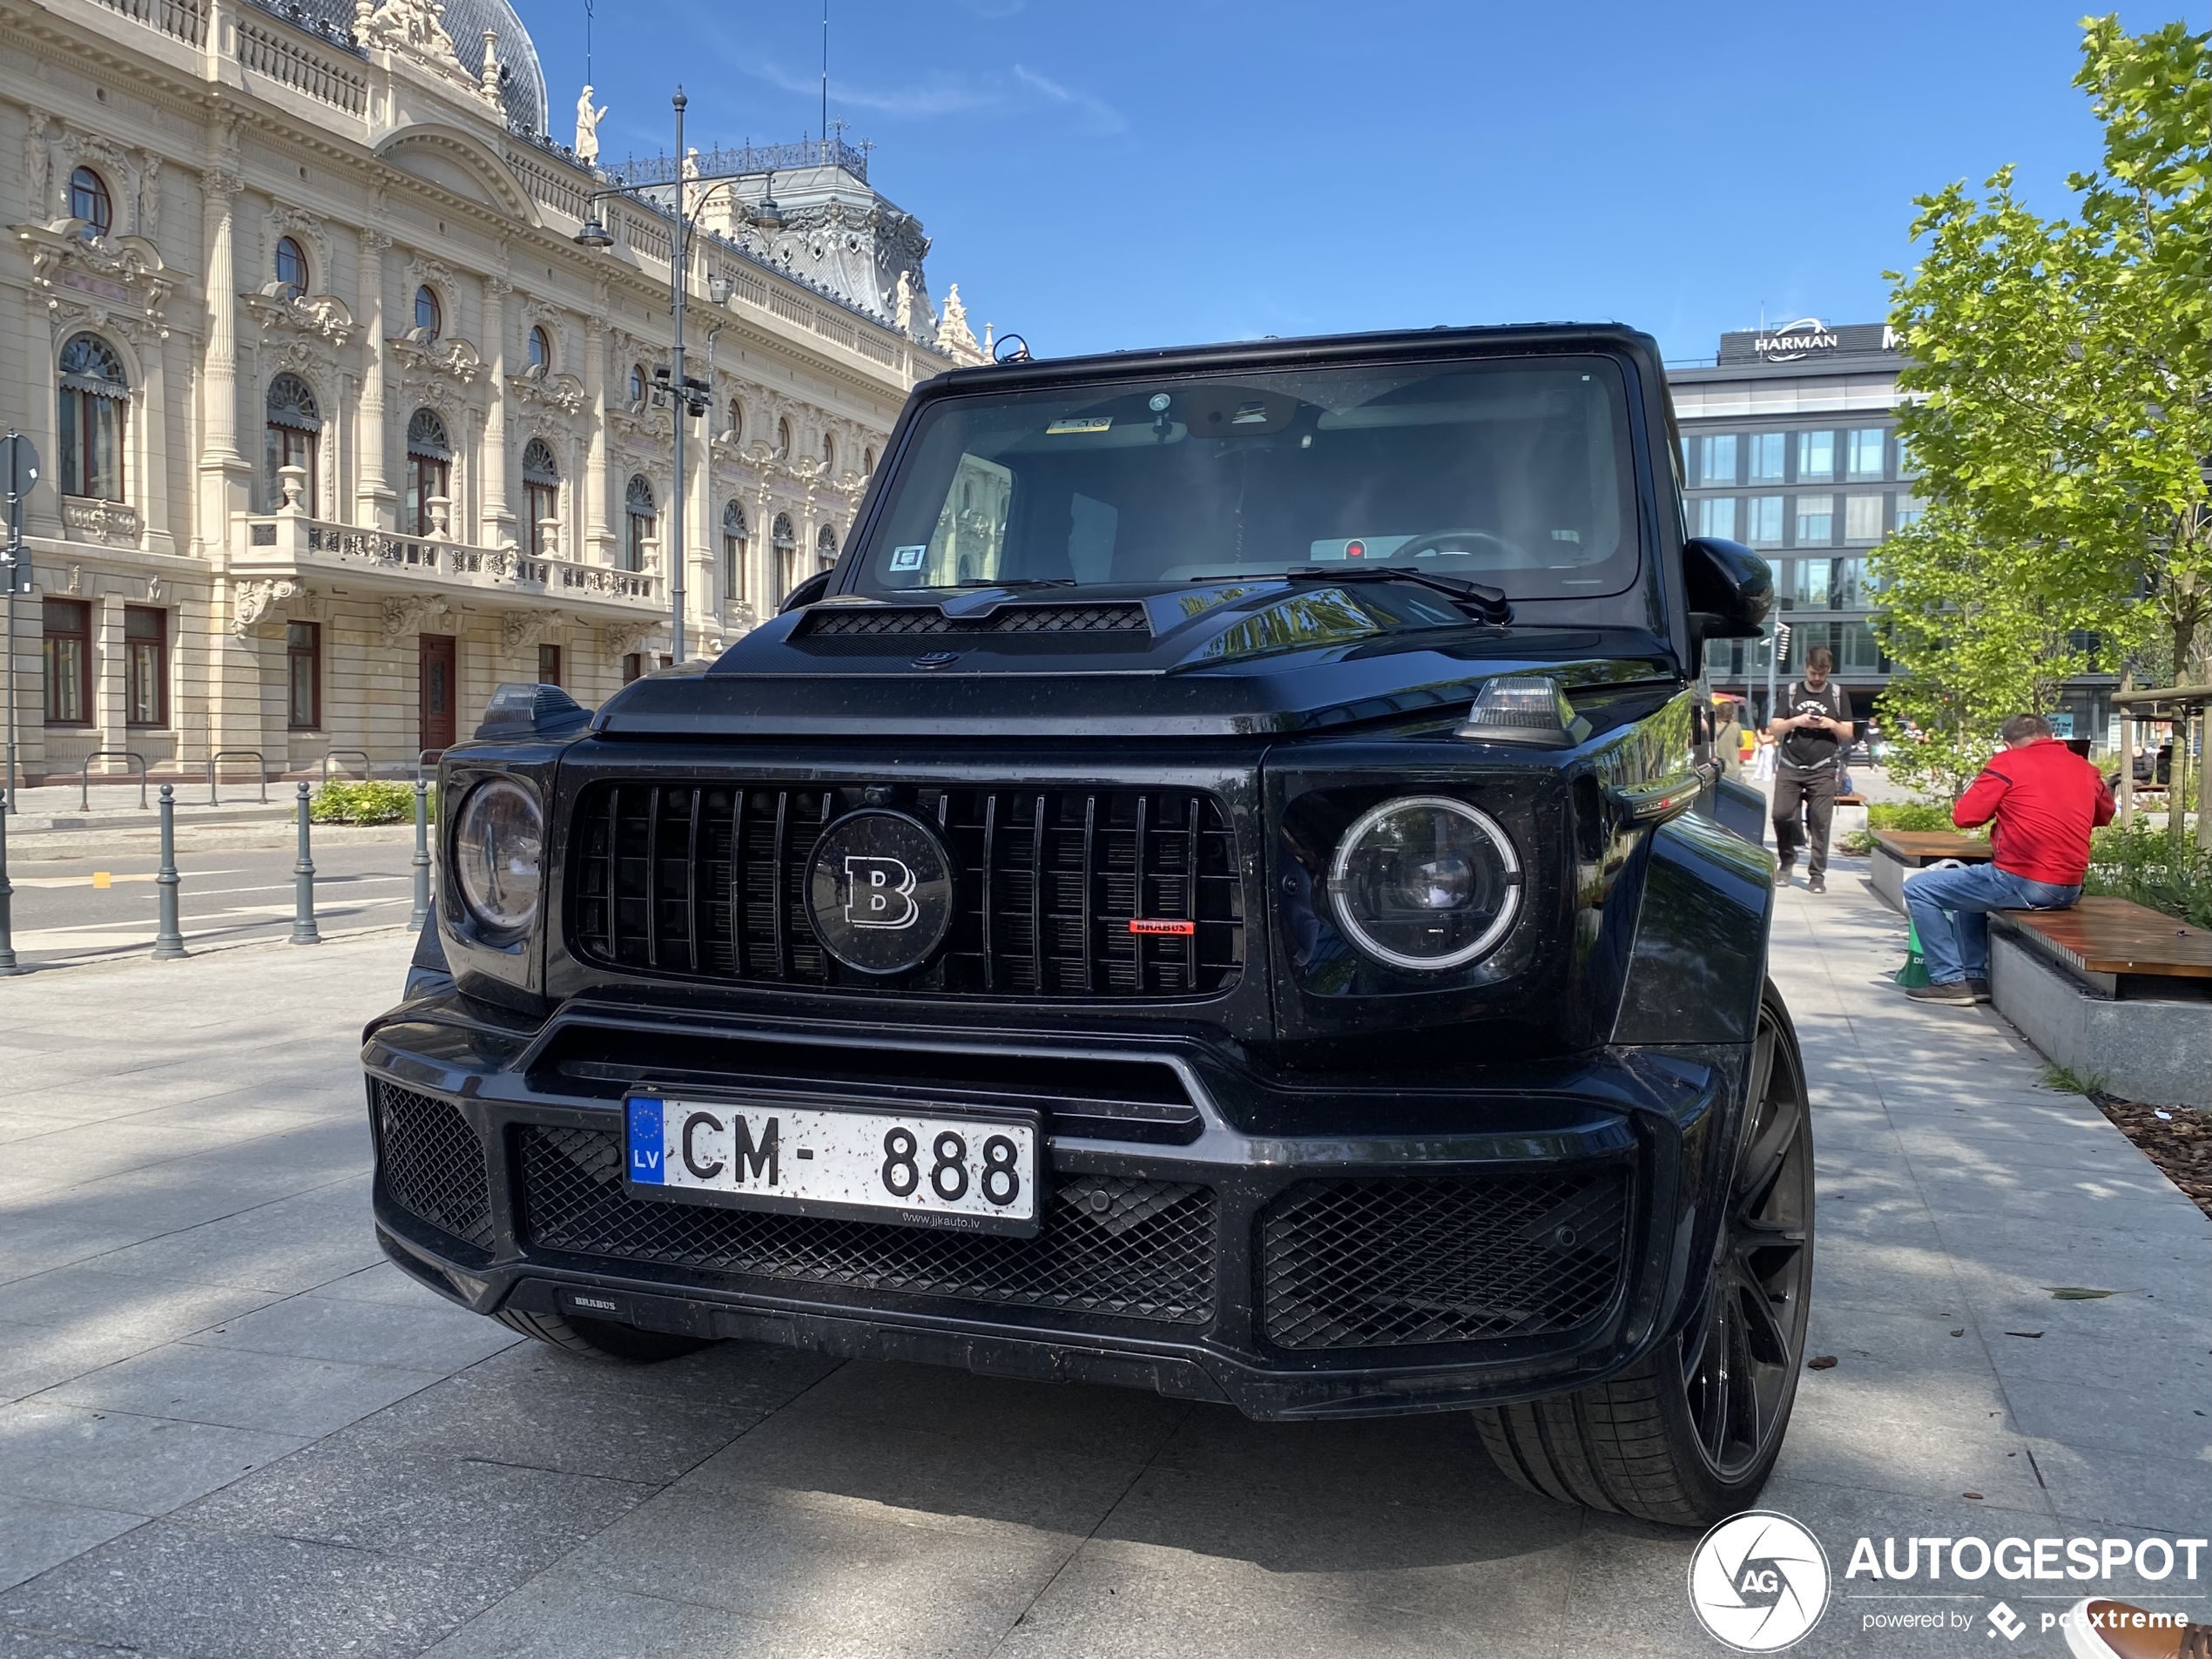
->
xmin=1905 ymin=714 xmax=2113 ymax=1007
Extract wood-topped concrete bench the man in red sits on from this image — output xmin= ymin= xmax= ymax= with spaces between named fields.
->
xmin=1988 ymin=896 xmax=2212 ymax=1106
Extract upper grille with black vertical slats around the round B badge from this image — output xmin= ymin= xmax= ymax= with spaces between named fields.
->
xmin=570 ymin=783 xmax=1243 ymax=998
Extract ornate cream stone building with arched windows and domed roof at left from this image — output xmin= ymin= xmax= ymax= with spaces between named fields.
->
xmin=0 ymin=0 xmax=980 ymax=781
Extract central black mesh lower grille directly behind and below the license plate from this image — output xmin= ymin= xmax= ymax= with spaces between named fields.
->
xmin=522 ymin=1128 xmax=1214 ymax=1325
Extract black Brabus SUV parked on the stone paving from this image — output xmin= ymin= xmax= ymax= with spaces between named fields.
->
xmin=363 ymin=325 xmax=1811 ymax=1524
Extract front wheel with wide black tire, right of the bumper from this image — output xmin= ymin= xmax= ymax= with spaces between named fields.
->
xmin=1475 ymin=984 xmax=1814 ymax=1527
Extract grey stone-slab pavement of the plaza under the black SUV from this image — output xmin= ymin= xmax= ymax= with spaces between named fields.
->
xmin=0 ymin=859 xmax=2212 ymax=1656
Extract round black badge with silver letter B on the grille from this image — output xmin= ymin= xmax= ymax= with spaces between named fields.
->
xmin=807 ymin=807 xmax=954 ymax=974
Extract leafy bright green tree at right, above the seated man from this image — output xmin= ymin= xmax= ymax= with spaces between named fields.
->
xmin=1876 ymin=17 xmax=2212 ymax=792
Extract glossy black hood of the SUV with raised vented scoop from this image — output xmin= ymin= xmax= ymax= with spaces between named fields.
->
xmin=595 ymin=582 xmax=1679 ymax=737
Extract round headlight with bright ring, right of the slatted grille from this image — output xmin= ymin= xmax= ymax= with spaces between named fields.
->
xmin=1330 ymin=794 xmax=1522 ymax=974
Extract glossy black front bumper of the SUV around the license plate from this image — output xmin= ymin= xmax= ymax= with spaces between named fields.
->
xmin=363 ymin=995 xmax=1743 ymax=1418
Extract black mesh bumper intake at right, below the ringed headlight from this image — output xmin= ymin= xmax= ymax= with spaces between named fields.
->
xmin=1261 ymin=1168 xmax=1628 ymax=1349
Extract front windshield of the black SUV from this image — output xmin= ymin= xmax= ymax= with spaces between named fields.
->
xmin=856 ymin=356 xmax=1637 ymax=599
